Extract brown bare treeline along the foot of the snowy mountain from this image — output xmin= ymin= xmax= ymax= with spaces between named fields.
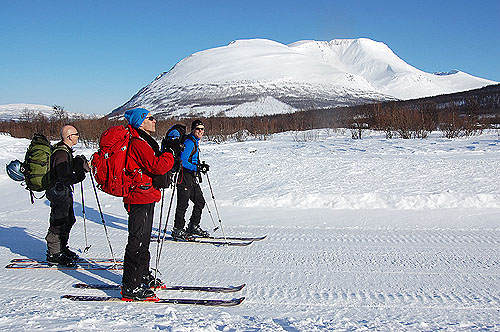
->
xmin=0 ymin=85 xmax=500 ymax=145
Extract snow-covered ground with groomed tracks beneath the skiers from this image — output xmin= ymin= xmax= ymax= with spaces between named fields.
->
xmin=0 ymin=130 xmax=500 ymax=331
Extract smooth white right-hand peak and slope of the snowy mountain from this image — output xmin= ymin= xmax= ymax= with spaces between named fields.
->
xmin=289 ymin=38 xmax=497 ymax=100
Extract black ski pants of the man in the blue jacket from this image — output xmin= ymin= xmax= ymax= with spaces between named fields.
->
xmin=174 ymin=169 xmax=205 ymax=229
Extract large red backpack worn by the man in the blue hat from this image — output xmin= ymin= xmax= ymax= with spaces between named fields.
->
xmin=92 ymin=126 xmax=132 ymax=197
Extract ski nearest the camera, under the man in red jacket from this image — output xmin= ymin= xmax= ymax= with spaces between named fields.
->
xmin=62 ymin=295 xmax=245 ymax=307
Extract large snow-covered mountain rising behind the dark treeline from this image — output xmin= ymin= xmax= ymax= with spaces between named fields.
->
xmin=111 ymin=38 xmax=497 ymax=116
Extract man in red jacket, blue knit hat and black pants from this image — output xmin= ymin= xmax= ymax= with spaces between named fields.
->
xmin=122 ymin=108 xmax=174 ymax=301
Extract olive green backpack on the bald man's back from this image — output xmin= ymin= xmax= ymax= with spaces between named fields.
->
xmin=23 ymin=134 xmax=66 ymax=202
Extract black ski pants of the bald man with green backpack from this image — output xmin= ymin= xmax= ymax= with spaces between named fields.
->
xmin=45 ymin=183 xmax=76 ymax=255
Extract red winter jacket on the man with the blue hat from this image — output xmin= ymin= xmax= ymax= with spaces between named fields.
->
xmin=123 ymin=126 xmax=174 ymax=204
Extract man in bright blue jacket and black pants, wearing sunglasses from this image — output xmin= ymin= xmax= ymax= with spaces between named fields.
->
xmin=172 ymin=120 xmax=209 ymax=241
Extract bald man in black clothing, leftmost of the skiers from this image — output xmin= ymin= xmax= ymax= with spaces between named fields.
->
xmin=45 ymin=125 xmax=90 ymax=266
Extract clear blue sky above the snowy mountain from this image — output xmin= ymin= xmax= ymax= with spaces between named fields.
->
xmin=0 ymin=0 xmax=500 ymax=114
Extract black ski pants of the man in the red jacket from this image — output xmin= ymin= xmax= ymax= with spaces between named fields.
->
xmin=122 ymin=203 xmax=155 ymax=289
